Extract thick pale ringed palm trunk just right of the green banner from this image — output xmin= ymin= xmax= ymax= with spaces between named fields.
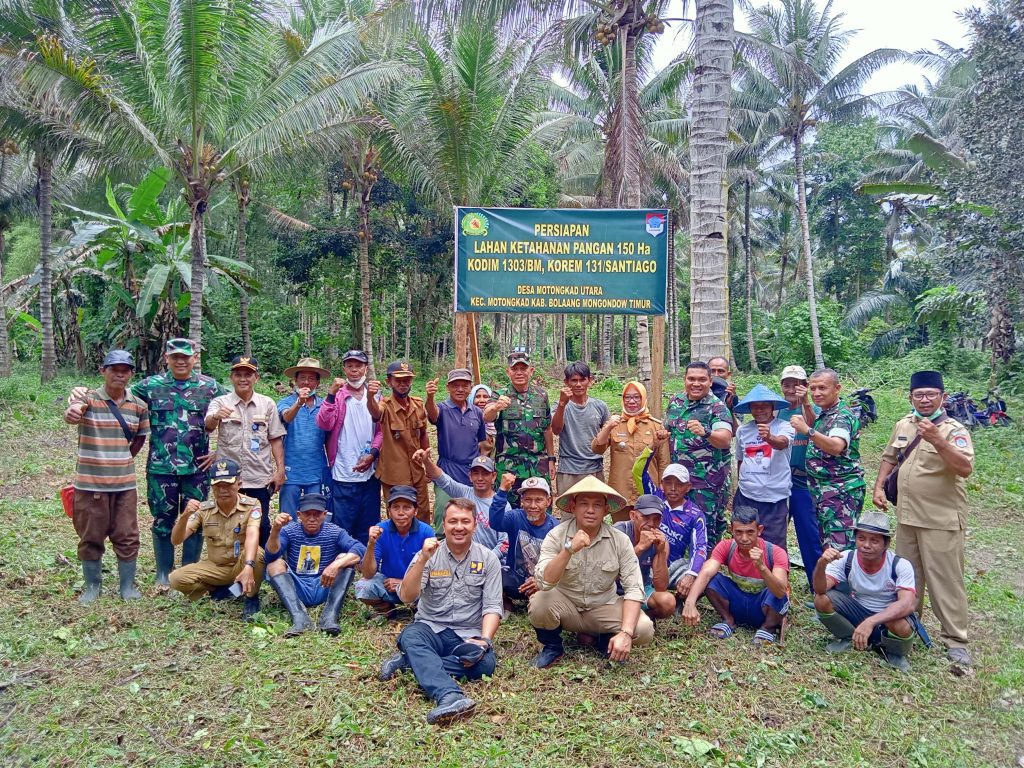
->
xmin=690 ymin=0 xmax=733 ymax=360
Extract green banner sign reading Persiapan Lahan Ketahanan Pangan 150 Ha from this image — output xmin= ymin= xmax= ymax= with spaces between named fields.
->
xmin=455 ymin=208 xmax=670 ymax=314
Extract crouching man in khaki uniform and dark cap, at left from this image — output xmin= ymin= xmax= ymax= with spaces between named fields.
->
xmin=171 ymin=460 xmax=263 ymax=621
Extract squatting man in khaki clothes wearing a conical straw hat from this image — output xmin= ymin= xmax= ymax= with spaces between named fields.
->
xmin=529 ymin=477 xmax=654 ymax=669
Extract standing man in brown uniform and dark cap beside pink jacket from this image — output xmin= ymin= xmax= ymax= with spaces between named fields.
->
xmin=367 ymin=360 xmax=431 ymax=524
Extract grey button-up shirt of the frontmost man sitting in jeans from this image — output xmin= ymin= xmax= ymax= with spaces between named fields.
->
xmin=410 ymin=542 xmax=502 ymax=639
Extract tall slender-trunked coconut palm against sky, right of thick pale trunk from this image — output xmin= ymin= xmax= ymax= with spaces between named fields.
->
xmin=738 ymin=0 xmax=906 ymax=368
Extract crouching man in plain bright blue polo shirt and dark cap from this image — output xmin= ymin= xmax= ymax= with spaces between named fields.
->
xmin=355 ymin=485 xmax=434 ymax=620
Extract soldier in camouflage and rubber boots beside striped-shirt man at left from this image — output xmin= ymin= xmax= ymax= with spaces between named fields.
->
xmin=131 ymin=339 xmax=227 ymax=587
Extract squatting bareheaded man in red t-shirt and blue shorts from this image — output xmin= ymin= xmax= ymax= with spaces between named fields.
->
xmin=683 ymin=507 xmax=790 ymax=645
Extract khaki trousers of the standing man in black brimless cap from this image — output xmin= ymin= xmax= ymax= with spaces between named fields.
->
xmin=896 ymin=523 xmax=968 ymax=648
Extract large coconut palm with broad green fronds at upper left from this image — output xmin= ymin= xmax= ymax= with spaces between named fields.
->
xmin=0 ymin=0 xmax=395 ymax=364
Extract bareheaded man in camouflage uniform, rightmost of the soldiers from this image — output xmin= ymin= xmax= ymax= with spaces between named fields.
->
xmin=790 ymin=368 xmax=864 ymax=551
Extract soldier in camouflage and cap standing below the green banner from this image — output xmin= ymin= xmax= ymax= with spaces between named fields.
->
xmin=483 ymin=347 xmax=555 ymax=507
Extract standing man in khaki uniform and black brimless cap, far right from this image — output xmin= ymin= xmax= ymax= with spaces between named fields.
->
xmin=872 ymin=371 xmax=974 ymax=666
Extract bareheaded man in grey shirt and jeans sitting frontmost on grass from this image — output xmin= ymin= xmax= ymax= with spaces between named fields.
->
xmin=380 ymin=499 xmax=502 ymax=724
